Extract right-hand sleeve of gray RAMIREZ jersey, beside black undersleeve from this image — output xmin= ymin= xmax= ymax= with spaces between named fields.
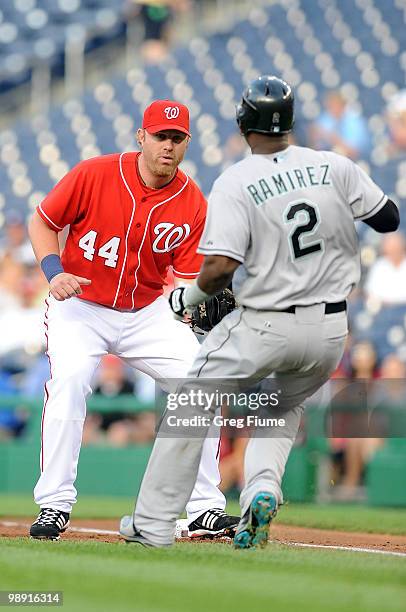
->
xmin=346 ymin=160 xmax=388 ymax=221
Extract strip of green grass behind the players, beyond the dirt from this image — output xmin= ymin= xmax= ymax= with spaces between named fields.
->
xmin=0 ymin=494 xmax=406 ymax=535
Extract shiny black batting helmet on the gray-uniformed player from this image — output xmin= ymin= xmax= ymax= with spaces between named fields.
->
xmin=236 ymin=75 xmax=294 ymax=136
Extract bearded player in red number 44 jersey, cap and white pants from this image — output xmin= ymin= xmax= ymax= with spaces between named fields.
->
xmin=29 ymin=100 xmax=239 ymax=539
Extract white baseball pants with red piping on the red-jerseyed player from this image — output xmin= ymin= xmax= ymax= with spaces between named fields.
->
xmin=34 ymin=296 xmax=226 ymax=522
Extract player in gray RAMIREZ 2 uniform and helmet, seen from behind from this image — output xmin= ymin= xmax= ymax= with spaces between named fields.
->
xmin=120 ymin=76 xmax=399 ymax=548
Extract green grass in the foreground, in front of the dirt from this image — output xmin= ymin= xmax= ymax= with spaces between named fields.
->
xmin=0 ymin=539 xmax=406 ymax=612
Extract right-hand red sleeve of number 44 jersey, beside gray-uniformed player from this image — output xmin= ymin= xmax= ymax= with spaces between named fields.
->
xmin=172 ymin=194 xmax=207 ymax=278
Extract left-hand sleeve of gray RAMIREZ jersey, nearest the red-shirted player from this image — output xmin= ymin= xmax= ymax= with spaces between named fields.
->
xmin=198 ymin=185 xmax=250 ymax=263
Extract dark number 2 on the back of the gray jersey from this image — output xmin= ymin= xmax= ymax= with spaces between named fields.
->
xmin=285 ymin=200 xmax=324 ymax=261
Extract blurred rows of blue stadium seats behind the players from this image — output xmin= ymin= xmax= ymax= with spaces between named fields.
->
xmin=0 ymin=0 xmax=406 ymax=320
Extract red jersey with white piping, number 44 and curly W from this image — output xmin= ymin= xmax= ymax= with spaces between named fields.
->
xmin=37 ymin=152 xmax=207 ymax=310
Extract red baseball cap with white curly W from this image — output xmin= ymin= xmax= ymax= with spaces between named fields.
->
xmin=142 ymin=100 xmax=190 ymax=136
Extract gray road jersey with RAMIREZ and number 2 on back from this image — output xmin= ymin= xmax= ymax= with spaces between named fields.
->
xmin=198 ymin=145 xmax=387 ymax=310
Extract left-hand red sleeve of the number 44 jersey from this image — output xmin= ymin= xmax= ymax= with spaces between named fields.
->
xmin=37 ymin=164 xmax=85 ymax=232
